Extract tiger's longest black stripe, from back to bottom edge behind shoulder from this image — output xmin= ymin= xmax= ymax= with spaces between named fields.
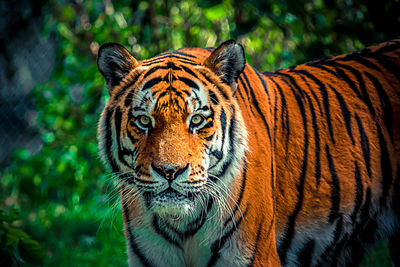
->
xmin=278 ymin=78 xmax=309 ymax=265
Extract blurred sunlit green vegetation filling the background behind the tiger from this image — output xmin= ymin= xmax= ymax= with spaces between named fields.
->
xmin=0 ymin=0 xmax=400 ymax=266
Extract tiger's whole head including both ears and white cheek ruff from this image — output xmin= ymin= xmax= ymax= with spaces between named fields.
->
xmin=98 ymin=41 xmax=247 ymax=220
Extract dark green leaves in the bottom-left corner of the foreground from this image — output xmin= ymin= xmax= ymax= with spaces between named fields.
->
xmin=0 ymin=209 xmax=44 ymax=266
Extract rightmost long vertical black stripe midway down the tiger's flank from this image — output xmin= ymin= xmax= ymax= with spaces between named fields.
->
xmin=377 ymin=127 xmax=393 ymax=205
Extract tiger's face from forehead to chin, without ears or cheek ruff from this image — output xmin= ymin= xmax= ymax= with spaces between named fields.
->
xmin=126 ymin=68 xmax=220 ymax=217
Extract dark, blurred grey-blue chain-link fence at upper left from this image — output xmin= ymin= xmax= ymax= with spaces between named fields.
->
xmin=0 ymin=1 xmax=55 ymax=169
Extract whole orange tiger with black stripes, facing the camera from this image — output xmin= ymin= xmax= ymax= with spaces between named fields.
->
xmin=97 ymin=40 xmax=400 ymax=267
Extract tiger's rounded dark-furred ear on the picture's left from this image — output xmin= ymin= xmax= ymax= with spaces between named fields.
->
xmin=97 ymin=43 xmax=138 ymax=93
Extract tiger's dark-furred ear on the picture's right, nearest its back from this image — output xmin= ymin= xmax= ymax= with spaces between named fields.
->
xmin=204 ymin=40 xmax=246 ymax=90
